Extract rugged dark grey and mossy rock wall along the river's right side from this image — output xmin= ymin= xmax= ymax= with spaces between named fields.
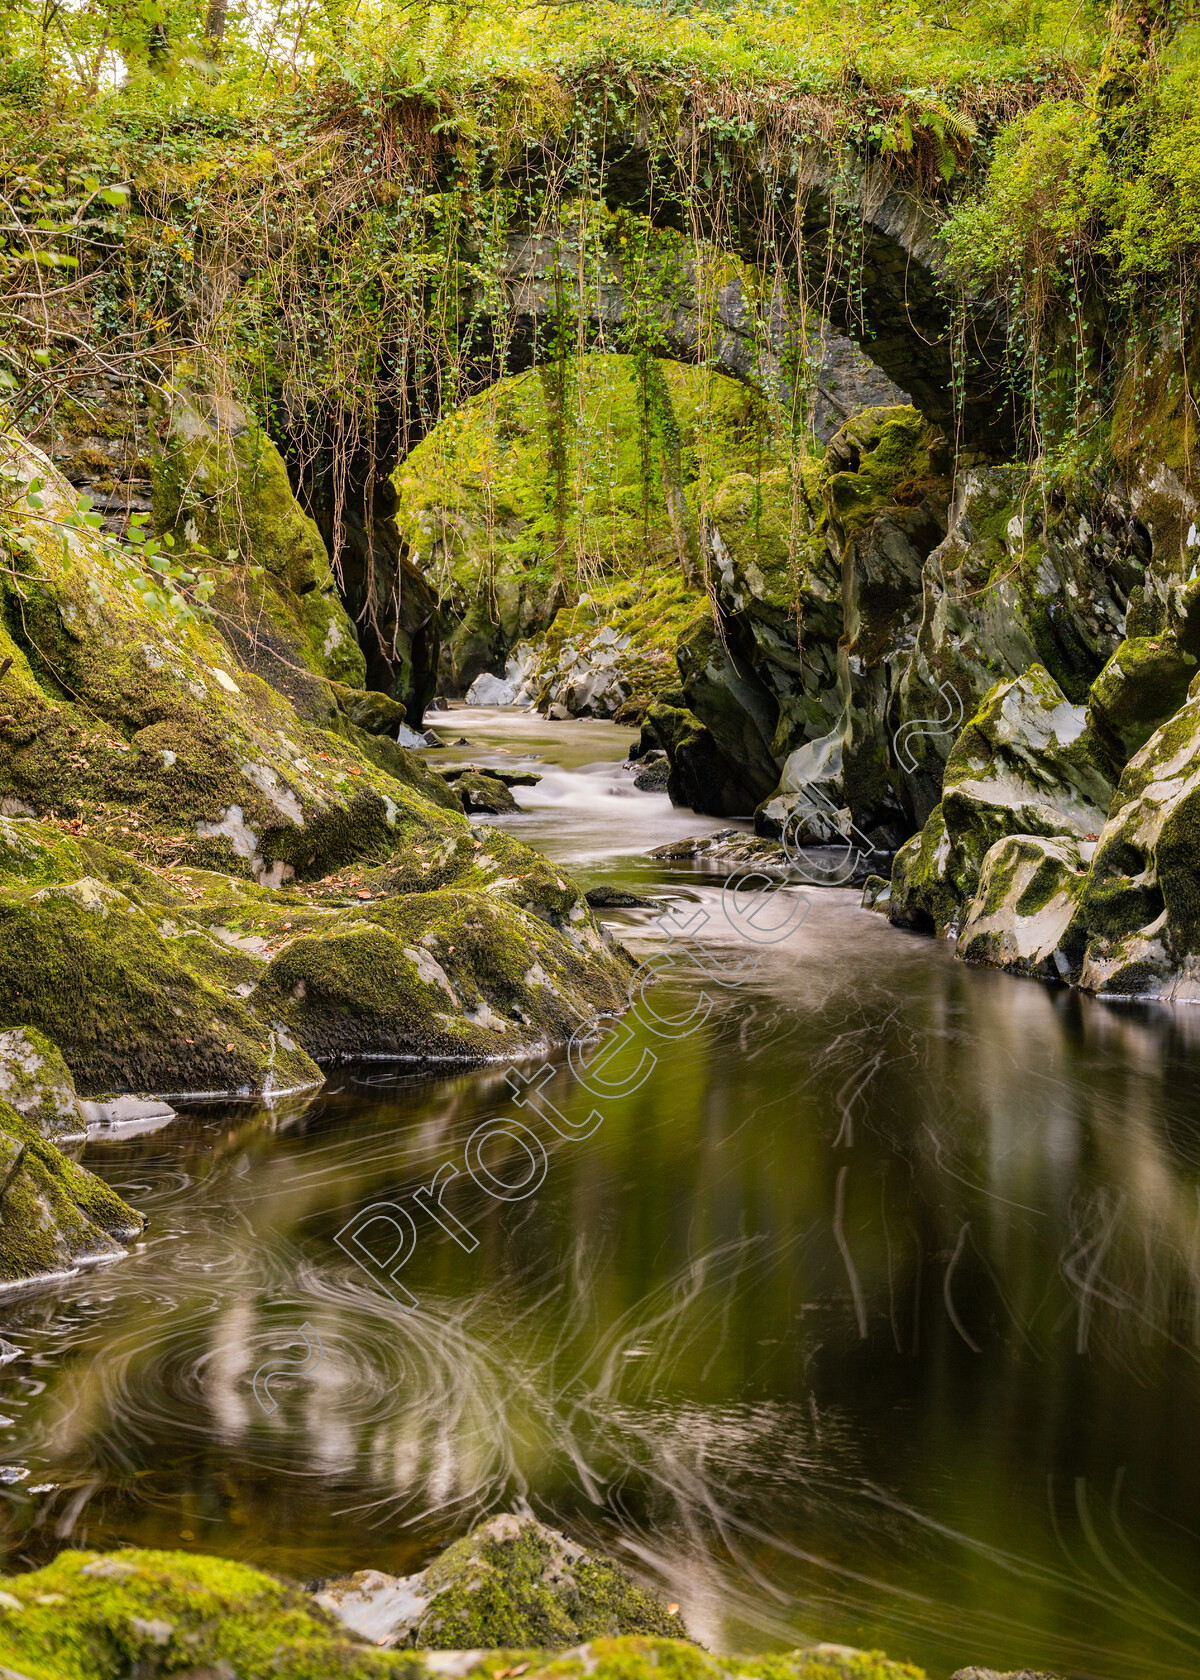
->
xmin=418 ymin=304 xmax=1200 ymax=1000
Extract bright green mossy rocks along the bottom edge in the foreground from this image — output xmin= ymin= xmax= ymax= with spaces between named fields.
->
xmin=0 ymin=1517 xmax=987 ymax=1680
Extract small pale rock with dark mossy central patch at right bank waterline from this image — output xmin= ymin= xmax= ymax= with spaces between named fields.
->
xmin=958 ymin=835 xmax=1094 ymax=981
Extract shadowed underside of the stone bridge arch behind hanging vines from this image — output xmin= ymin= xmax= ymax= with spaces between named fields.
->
xmin=284 ymin=136 xmax=1015 ymax=714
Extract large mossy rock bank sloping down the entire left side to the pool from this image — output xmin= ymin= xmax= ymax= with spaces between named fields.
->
xmin=0 ymin=433 xmax=632 ymax=1102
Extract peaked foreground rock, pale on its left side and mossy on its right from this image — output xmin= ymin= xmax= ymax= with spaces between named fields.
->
xmin=318 ymin=1515 xmax=686 ymax=1650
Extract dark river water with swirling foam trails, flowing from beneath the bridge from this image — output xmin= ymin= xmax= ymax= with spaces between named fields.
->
xmin=0 ymin=709 xmax=1200 ymax=1680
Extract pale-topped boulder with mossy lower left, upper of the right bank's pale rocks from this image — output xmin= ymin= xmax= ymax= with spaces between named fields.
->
xmin=891 ymin=665 xmax=1114 ymax=931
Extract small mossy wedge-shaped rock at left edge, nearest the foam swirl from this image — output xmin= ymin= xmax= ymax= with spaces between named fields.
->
xmin=0 ymin=1102 xmax=145 ymax=1287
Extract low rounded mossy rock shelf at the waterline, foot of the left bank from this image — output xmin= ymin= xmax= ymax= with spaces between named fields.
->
xmin=0 ymin=816 xmax=632 ymax=1095
